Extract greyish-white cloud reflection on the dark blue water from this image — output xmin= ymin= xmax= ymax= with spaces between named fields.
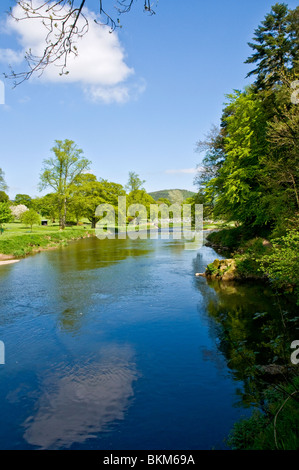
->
xmin=24 ymin=345 xmax=137 ymax=449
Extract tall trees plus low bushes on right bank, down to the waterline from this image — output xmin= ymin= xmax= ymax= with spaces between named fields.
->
xmin=192 ymin=3 xmax=299 ymax=301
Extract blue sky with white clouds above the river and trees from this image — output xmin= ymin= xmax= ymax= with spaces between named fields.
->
xmin=0 ymin=0 xmax=296 ymax=198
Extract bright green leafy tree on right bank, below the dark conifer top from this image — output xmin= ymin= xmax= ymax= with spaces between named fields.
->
xmin=206 ymin=89 xmax=269 ymax=225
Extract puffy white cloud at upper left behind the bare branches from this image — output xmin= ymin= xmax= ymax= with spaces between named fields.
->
xmin=0 ymin=0 xmax=145 ymax=103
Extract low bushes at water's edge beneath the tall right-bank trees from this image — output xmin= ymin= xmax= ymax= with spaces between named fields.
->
xmin=204 ymin=227 xmax=299 ymax=305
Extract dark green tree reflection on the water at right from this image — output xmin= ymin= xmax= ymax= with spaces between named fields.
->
xmin=198 ymin=281 xmax=299 ymax=406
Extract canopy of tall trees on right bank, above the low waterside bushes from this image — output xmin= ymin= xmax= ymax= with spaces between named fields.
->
xmin=195 ymin=3 xmax=299 ymax=233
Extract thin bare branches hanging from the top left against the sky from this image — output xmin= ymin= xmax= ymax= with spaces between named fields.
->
xmin=6 ymin=0 xmax=154 ymax=85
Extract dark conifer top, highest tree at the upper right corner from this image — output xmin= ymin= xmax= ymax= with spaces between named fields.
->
xmin=245 ymin=3 xmax=299 ymax=89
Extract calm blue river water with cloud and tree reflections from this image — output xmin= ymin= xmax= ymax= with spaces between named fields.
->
xmin=0 ymin=238 xmax=288 ymax=450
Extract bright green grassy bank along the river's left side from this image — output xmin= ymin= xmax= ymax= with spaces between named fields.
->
xmin=0 ymin=223 xmax=94 ymax=260
